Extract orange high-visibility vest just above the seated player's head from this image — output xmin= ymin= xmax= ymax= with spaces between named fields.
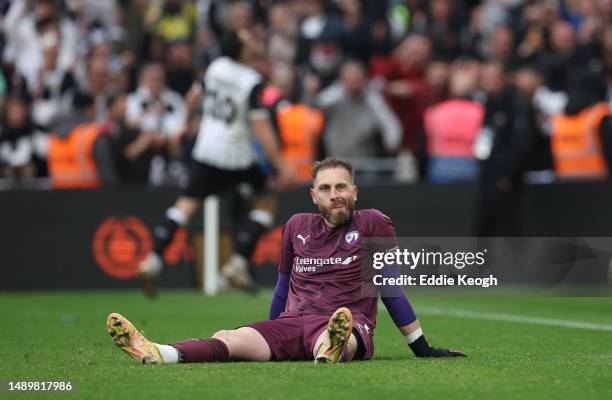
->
xmin=276 ymin=104 xmax=324 ymax=181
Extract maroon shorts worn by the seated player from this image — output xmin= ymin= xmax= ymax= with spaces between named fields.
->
xmin=244 ymin=314 xmax=374 ymax=361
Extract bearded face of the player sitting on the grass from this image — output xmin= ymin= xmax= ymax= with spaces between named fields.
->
xmin=310 ymin=168 xmax=357 ymax=227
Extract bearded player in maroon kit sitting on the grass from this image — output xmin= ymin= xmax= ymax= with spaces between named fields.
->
xmin=107 ymin=158 xmax=464 ymax=364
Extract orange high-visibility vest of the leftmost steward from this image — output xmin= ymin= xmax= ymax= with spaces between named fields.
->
xmin=48 ymin=123 xmax=101 ymax=189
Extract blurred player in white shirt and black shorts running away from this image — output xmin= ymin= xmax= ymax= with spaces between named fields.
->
xmin=139 ymin=30 xmax=293 ymax=290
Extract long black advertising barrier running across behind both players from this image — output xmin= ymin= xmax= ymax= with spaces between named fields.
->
xmin=0 ymin=184 xmax=612 ymax=290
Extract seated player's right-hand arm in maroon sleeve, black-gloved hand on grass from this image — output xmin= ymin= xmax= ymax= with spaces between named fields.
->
xmin=371 ymin=212 xmax=465 ymax=357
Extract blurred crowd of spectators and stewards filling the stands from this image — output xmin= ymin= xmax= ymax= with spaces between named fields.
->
xmin=0 ymin=0 xmax=612 ymax=191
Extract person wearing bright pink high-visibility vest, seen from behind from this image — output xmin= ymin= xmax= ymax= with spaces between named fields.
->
xmin=418 ymin=61 xmax=484 ymax=183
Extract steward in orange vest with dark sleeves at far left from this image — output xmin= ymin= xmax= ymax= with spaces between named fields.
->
xmin=48 ymin=93 xmax=117 ymax=189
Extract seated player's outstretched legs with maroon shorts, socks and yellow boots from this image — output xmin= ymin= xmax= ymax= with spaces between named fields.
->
xmin=106 ymin=307 xmax=366 ymax=365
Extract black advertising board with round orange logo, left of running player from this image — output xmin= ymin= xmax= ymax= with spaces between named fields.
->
xmin=0 ymin=188 xmax=192 ymax=289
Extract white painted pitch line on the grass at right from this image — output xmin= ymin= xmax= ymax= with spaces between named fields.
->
xmin=417 ymin=307 xmax=612 ymax=332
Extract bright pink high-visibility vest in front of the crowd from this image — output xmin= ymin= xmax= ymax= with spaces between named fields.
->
xmin=424 ymin=99 xmax=484 ymax=158
